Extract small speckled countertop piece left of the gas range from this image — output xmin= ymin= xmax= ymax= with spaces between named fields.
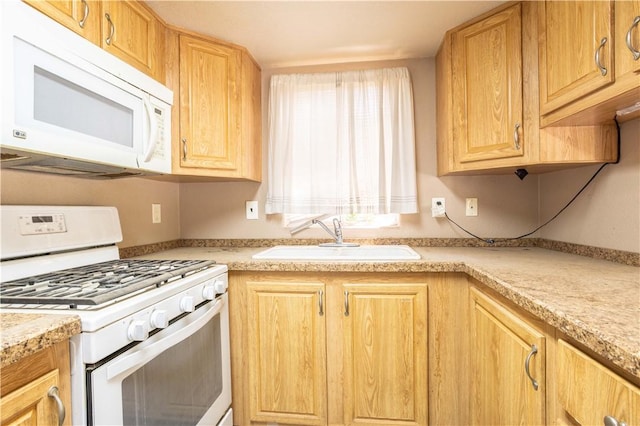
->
xmin=0 ymin=310 xmax=80 ymax=368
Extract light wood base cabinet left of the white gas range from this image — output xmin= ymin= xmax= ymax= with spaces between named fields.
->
xmin=0 ymin=341 xmax=71 ymax=426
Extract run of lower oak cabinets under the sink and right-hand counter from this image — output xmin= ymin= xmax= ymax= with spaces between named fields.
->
xmin=231 ymin=271 xmax=640 ymax=426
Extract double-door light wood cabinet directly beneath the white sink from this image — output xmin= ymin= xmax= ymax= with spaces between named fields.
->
xmin=229 ymin=272 xmax=430 ymax=425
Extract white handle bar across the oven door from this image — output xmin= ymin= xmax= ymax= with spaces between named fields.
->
xmin=107 ymin=297 xmax=225 ymax=380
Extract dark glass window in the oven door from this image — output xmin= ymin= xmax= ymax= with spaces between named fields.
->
xmin=122 ymin=315 xmax=222 ymax=426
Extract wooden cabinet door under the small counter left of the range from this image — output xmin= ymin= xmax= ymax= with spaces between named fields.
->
xmin=0 ymin=370 xmax=60 ymax=426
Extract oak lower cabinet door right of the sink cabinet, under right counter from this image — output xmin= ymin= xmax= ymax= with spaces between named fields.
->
xmin=470 ymin=288 xmax=546 ymax=425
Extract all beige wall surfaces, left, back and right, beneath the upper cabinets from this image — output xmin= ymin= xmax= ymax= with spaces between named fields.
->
xmin=0 ymin=55 xmax=640 ymax=252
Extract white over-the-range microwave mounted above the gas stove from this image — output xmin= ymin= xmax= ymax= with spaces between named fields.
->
xmin=0 ymin=1 xmax=173 ymax=178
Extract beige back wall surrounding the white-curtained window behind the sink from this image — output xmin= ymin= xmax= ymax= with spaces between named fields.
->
xmin=180 ymin=58 xmax=538 ymax=239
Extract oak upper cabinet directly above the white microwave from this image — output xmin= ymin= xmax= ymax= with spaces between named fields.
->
xmin=25 ymin=0 xmax=165 ymax=82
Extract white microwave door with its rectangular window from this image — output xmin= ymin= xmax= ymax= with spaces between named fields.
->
xmin=10 ymin=37 xmax=145 ymax=168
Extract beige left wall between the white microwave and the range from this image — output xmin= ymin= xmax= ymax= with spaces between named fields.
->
xmin=0 ymin=170 xmax=180 ymax=247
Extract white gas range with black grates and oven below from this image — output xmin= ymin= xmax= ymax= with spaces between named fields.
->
xmin=0 ymin=206 xmax=232 ymax=426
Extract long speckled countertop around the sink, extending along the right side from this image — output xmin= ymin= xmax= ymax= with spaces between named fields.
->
xmin=142 ymin=247 xmax=640 ymax=379
